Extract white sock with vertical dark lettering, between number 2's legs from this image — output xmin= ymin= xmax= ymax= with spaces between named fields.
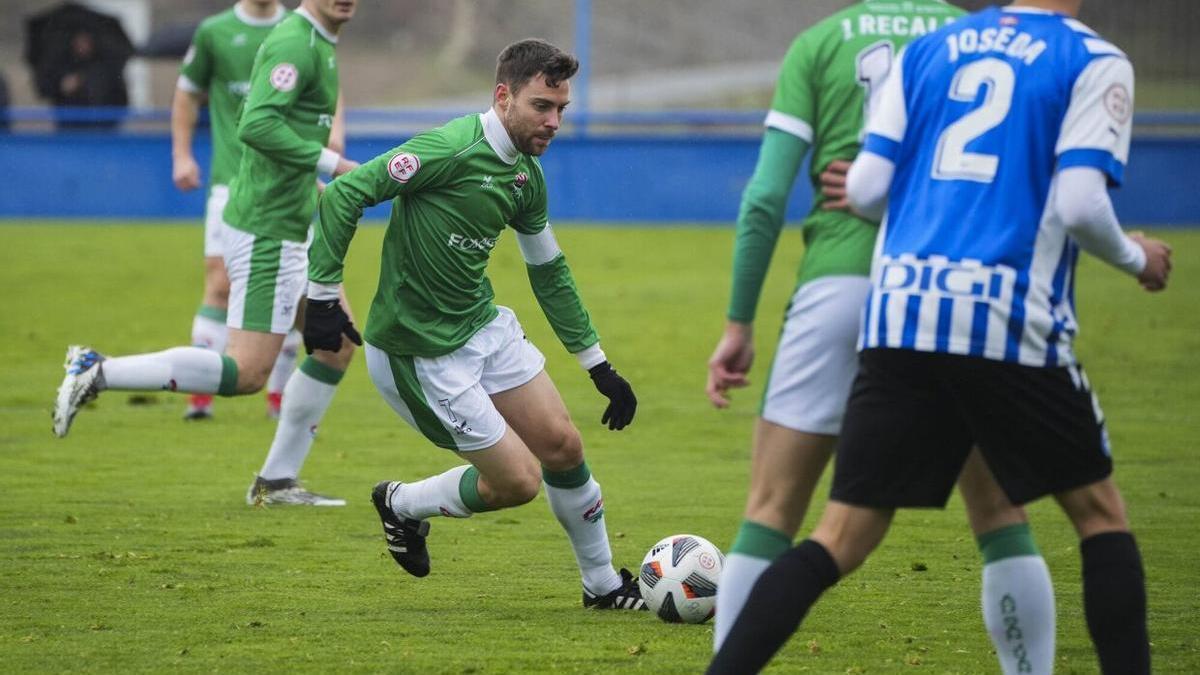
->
xmin=979 ymin=555 xmax=1055 ymax=675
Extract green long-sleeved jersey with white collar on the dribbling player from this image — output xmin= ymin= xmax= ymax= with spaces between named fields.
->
xmin=308 ymin=110 xmax=599 ymax=357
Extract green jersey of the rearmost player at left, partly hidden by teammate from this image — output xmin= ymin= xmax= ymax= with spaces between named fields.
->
xmin=179 ymin=5 xmax=287 ymax=185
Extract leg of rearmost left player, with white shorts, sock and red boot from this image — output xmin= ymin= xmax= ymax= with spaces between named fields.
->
xmin=184 ymin=185 xmax=229 ymax=419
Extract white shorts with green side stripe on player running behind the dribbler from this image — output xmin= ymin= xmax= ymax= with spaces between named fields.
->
xmin=221 ymin=227 xmax=308 ymax=335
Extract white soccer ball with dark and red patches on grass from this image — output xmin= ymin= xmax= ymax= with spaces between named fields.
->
xmin=641 ymin=534 xmax=725 ymax=623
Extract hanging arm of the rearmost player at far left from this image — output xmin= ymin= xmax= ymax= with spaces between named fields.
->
xmin=170 ymin=26 xmax=212 ymax=192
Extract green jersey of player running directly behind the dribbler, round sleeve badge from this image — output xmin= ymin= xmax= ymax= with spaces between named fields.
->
xmin=224 ymin=8 xmax=338 ymax=241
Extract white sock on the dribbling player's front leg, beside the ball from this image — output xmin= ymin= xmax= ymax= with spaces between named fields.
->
xmin=546 ymin=477 xmax=620 ymax=596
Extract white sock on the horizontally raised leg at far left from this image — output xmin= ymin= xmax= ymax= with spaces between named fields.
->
xmin=101 ymin=347 xmax=222 ymax=394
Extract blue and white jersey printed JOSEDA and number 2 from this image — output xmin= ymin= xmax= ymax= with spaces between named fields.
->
xmin=860 ymin=7 xmax=1133 ymax=366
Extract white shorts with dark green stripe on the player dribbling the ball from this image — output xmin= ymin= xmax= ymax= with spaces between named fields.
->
xmin=366 ymin=307 xmax=546 ymax=452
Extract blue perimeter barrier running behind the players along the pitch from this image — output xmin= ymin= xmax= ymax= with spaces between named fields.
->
xmin=0 ymin=112 xmax=1200 ymax=225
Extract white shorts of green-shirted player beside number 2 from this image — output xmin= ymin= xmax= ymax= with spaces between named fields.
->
xmin=761 ymin=276 xmax=871 ymax=436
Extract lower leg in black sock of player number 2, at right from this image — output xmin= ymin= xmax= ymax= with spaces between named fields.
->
xmin=1055 ymin=478 xmax=1150 ymax=673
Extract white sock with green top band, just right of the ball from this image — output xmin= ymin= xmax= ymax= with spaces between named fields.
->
xmin=713 ymin=520 xmax=792 ymax=652
